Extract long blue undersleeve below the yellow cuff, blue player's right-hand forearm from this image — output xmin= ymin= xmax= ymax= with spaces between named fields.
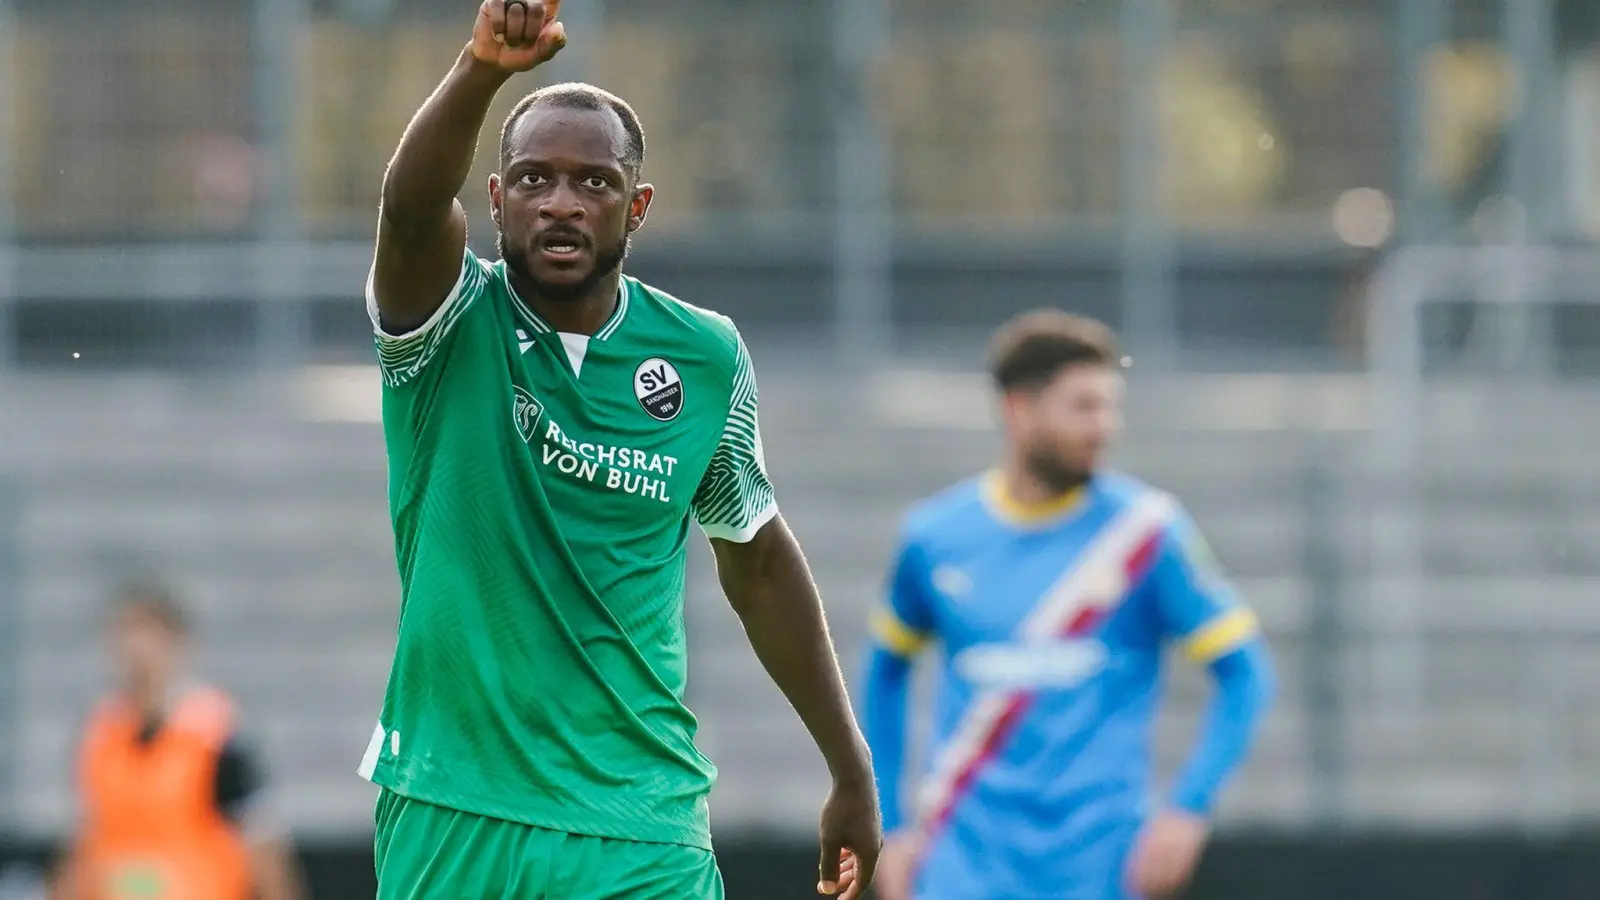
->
xmin=1173 ymin=639 xmax=1275 ymax=815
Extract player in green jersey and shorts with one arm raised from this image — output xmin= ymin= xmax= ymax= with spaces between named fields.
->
xmin=362 ymin=0 xmax=880 ymax=900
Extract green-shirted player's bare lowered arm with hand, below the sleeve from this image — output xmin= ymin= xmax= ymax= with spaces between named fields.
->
xmin=712 ymin=517 xmax=883 ymax=900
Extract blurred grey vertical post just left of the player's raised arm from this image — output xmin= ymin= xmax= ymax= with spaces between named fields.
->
xmin=251 ymin=0 xmax=310 ymax=368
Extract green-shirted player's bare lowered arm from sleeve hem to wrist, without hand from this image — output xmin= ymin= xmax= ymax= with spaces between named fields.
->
xmin=717 ymin=519 xmax=872 ymax=781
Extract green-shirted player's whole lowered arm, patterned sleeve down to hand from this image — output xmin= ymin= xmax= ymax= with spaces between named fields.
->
xmin=694 ymin=333 xmax=882 ymax=900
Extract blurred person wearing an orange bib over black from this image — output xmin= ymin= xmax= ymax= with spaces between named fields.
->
xmin=51 ymin=583 xmax=302 ymax=900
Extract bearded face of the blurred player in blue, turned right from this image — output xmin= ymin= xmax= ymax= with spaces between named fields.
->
xmin=1005 ymin=365 xmax=1123 ymax=492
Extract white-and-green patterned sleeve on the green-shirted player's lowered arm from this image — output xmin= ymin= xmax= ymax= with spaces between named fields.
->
xmin=694 ymin=329 xmax=778 ymax=543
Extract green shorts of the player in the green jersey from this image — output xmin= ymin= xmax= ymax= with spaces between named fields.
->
xmin=373 ymin=791 xmax=722 ymax=900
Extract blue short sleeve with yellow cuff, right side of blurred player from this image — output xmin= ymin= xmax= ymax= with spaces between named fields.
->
xmin=1150 ymin=514 xmax=1261 ymax=663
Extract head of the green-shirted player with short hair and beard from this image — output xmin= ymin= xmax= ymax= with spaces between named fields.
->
xmin=490 ymin=83 xmax=654 ymax=301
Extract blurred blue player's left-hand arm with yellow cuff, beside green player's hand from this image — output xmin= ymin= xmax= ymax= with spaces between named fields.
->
xmin=861 ymin=540 xmax=933 ymax=834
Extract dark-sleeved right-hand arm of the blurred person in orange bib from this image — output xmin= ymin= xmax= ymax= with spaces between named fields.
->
xmin=214 ymin=735 xmax=307 ymax=900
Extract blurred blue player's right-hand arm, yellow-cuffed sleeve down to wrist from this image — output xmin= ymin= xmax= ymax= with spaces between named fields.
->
xmin=1152 ymin=517 xmax=1275 ymax=817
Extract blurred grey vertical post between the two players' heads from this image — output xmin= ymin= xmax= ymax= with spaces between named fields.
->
xmin=832 ymin=0 xmax=894 ymax=372
